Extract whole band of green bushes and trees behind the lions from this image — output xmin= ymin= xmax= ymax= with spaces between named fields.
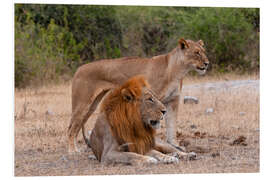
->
xmin=15 ymin=4 xmax=260 ymax=87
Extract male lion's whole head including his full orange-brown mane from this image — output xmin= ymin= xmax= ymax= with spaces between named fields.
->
xmin=102 ymin=76 xmax=166 ymax=154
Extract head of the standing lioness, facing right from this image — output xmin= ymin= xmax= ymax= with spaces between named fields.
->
xmin=177 ymin=38 xmax=209 ymax=75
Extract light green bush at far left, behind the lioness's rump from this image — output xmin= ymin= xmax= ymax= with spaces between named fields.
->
xmin=15 ymin=14 xmax=82 ymax=87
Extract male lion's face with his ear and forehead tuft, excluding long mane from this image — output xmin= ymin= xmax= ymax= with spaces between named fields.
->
xmin=121 ymin=76 xmax=166 ymax=129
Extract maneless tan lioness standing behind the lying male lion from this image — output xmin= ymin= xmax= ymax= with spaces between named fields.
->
xmin=68 ymin=39 xmax=209 ymax=152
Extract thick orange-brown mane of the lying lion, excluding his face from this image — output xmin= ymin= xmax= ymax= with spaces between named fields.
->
xmin=102 ymin=76 xmax=155 ymax=154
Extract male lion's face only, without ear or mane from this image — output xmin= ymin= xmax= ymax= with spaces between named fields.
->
xmin=140 ymin=88 xmax=166 ymax=129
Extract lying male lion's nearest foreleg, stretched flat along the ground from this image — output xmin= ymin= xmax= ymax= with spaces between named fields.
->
xmin=101 ymin=151 xmax=158 ymax=165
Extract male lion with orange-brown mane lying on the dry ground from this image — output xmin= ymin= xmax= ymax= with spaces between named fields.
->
xmin=87 ymin=76 xmax=191 ymax=164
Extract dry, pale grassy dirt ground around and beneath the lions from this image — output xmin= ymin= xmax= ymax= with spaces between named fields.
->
xmin=14 ymin=76 xmax=260 ymax=176
